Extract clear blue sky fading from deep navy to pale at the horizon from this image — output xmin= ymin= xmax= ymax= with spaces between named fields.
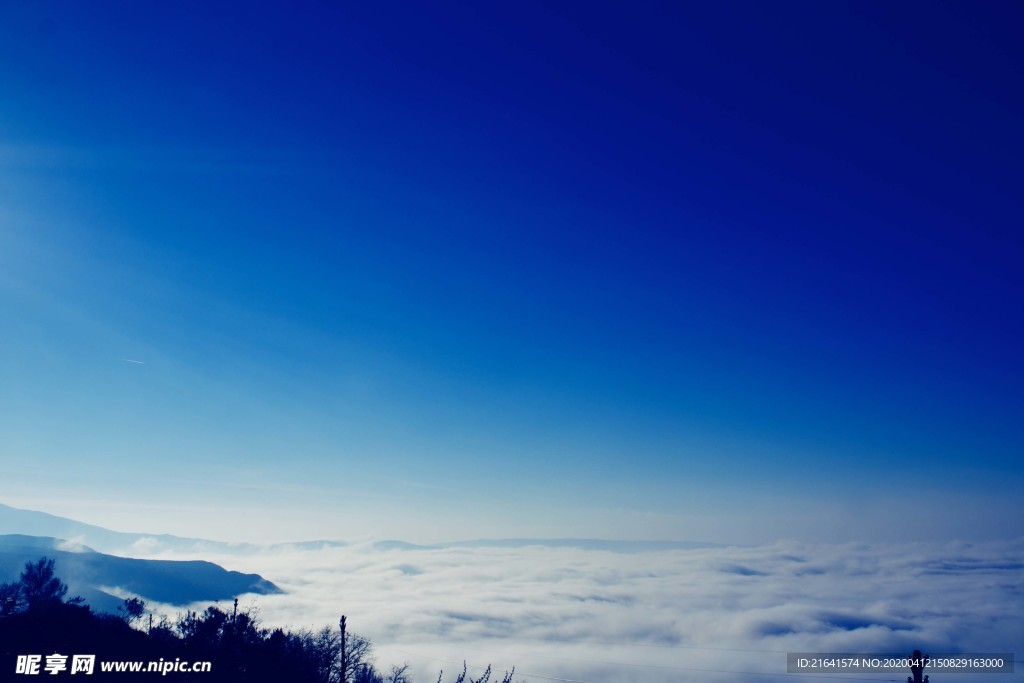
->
xmin=0 ymin=2 xmax=1024 ymax=542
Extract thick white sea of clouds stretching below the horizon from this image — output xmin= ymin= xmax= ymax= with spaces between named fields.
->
xmin=128 ymin=539 xmax=1024 ymax=683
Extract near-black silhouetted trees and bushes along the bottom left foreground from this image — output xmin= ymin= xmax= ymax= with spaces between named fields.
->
xmin=0 ymin=557 xmax=512 ymax=683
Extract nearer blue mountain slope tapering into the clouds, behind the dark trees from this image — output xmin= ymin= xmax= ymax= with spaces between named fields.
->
xmin=0 ymin=535 xmax=282 ymax=611
